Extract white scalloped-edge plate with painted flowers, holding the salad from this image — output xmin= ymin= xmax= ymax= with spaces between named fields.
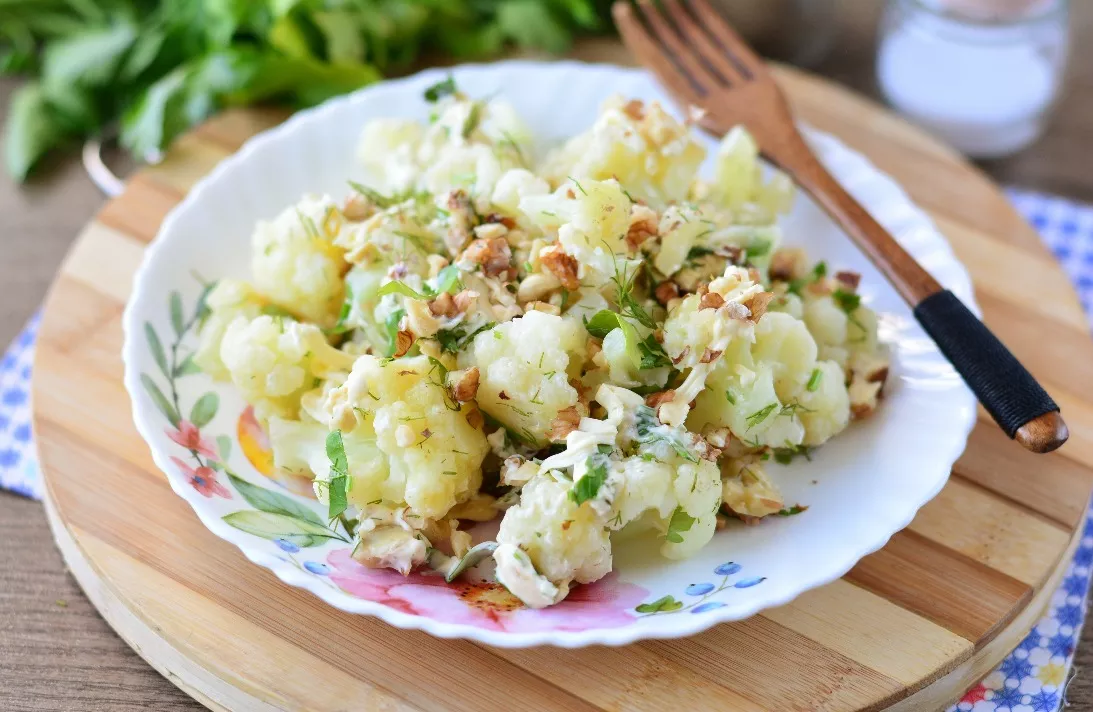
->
xmin=125 ymin=61 xmax=975 ymax=647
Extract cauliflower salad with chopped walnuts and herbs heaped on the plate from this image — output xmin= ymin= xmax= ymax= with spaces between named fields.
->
xmin=196 ymin=78 xmax=888 ymax=607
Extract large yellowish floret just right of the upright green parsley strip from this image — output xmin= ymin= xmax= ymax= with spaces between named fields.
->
xmin=325 ymin=355 xmax=490 ymax=518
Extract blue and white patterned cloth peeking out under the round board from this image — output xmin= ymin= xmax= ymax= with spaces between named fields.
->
xmin=0 ymin=190 xmax=1093 ymax=712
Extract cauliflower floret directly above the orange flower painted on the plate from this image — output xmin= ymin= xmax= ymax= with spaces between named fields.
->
xmin=220 ymin=315 xmax=353 ymax=420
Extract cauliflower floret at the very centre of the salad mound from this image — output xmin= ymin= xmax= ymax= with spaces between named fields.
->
xmin=459 ymin=312 xmax=587 ymax=445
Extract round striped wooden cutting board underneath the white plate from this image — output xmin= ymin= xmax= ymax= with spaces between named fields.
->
xmin=34 ymin=49 xmax=1093 ymax=712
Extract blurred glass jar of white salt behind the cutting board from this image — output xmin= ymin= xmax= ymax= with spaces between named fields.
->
xmin=877 ymin=0 xmax=1068 ymax=159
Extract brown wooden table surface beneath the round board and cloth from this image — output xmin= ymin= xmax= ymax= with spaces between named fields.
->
xmin=6 ymin=0 xmax=1093 ymax=712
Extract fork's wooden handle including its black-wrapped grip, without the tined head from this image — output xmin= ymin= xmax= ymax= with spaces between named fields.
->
xmin=771 ymin=148 xmax=1069 ymax=453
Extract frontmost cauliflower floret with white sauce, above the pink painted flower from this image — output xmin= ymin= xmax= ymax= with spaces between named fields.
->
xmin=494 ymin=472 xmax=611 ymax=607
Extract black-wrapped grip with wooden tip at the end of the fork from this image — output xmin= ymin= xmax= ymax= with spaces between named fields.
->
xmin=915 ymin=290 xmax=1068 ymax=452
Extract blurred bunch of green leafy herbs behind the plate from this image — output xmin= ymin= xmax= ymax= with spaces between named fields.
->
xmin=0 ymin=0 xmax=609 ymax=180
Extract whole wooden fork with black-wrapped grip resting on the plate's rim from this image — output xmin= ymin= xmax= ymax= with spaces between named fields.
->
xmin=612 ymin=0 xmax=1069 ymax=453
